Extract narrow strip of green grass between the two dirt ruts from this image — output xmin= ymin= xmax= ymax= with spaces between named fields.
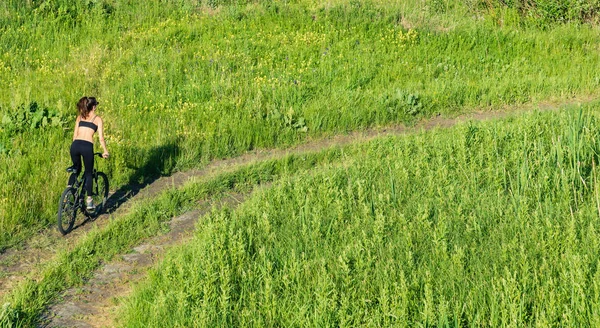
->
xmin=0 ymin=142 xmax=342 ymax=327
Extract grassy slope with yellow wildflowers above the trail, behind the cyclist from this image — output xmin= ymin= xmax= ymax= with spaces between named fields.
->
xmin=0 ymin=0 xmax=600 ymax=250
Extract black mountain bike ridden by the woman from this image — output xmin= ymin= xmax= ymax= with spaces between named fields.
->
xmin=58 ymin=153 xmax=108 ymax=235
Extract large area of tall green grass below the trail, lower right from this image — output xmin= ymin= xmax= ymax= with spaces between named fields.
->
xmin=121 ymin=104 xmax=600 ymax=327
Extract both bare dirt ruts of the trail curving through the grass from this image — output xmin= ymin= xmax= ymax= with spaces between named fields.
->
xmin=0 ymin=96 xmax=596 ymax=327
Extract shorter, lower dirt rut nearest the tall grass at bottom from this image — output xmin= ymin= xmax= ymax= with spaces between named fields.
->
xmin=41 ymin=188 xmax=254 ymax=327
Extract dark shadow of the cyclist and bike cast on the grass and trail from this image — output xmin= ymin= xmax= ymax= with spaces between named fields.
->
xmin=72 ymin=140 xmax=180 ymax=230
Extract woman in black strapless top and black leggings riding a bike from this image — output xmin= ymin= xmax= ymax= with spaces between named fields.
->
xmin=69 ymin=97 xmax=108 ymax=209
